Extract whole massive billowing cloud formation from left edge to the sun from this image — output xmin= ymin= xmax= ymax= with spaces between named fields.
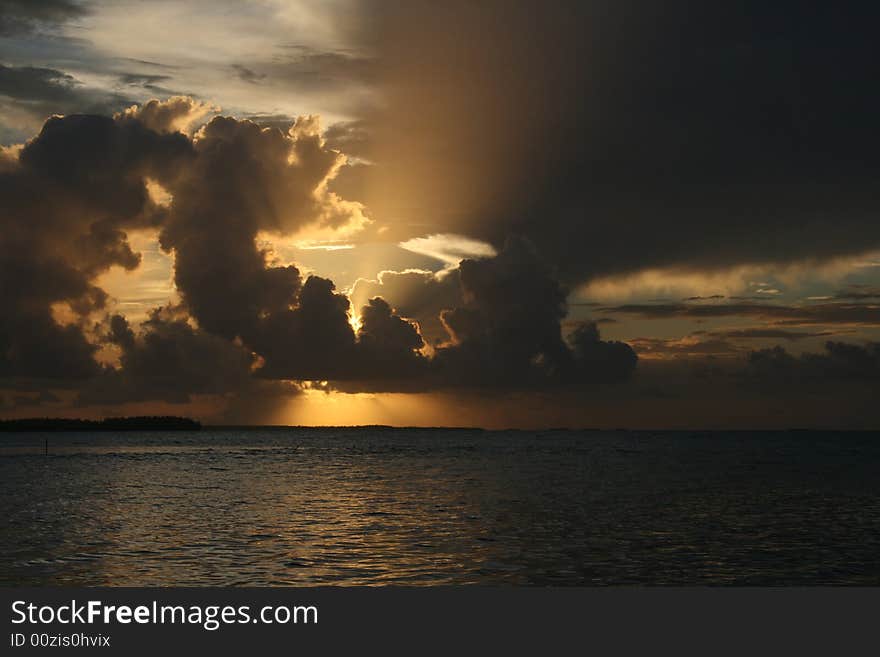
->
xmin=0 ymin=98 xmax=440 ymax=404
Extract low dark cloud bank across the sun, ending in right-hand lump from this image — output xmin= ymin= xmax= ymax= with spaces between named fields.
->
xmin=254 ymin=239 xmax=637 ymax=392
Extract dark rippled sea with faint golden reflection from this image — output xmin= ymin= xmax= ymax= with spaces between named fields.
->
xmin=0 ymin=429 xmax=880 ymax=585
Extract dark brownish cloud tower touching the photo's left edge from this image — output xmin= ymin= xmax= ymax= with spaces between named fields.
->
xmin=0 ymin=107 xmax=190 ymax=379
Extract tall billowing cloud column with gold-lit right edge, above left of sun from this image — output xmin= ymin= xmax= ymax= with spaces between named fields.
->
xmin=160 ymin=111 xmax=361 ymax=340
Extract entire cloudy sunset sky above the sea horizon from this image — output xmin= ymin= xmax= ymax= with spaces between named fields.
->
xmin=0 ymin=0 xmax=880 ymax=429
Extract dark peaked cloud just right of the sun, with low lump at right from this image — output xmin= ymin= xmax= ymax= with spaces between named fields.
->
xmin=432 ymin=239 xmax=637 ymax=388
